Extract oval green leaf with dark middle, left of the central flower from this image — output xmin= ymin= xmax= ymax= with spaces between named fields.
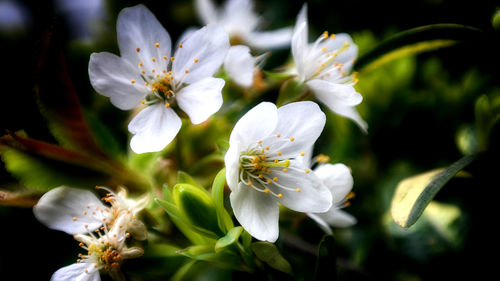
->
xmin=173 ymin=184 xmax=224 ymax=236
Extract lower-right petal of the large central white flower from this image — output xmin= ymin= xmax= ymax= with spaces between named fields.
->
xmin=268 ymin=161 xmax=332 ymax=213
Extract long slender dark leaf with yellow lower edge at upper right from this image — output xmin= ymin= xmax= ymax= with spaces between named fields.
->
xmin=354 ymin=24 xmax=482 ymax=71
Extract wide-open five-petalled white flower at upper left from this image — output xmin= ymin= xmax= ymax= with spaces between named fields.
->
xmin=89 ymin=5 xmax=229 ymax=153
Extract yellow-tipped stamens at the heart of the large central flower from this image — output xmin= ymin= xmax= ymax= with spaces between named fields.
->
xmin=239 ymin=134 xmax=309 ymax=198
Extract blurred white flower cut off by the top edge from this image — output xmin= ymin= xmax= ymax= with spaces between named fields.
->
xmin=196 ymin=0 xmax=292 ymax=49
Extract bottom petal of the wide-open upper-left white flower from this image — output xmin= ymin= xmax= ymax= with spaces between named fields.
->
xmin=128 ymin=103 xmax=182 ymax=153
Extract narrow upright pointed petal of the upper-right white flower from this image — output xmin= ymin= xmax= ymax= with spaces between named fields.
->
xmin=292 ymin=4 xmax=310 ymax=81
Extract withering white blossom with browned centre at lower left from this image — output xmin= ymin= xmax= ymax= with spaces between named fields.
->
xmin=33 ymin=187 xmax=149 ymax=281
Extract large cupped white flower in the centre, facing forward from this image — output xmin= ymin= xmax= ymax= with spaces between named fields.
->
xmin=224 ymin=101 xmax=332 ymax=242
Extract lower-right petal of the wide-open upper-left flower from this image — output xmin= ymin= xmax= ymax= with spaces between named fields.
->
xmin=177 ymin=77 xmax=225 ymax=124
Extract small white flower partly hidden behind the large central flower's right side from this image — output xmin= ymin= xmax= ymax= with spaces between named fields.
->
xmin=307 ymin=163 xmax=356 ymax=234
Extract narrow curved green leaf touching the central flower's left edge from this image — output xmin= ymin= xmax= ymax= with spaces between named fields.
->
xmin=212 ymin=168 xmax=234 ymax=233
